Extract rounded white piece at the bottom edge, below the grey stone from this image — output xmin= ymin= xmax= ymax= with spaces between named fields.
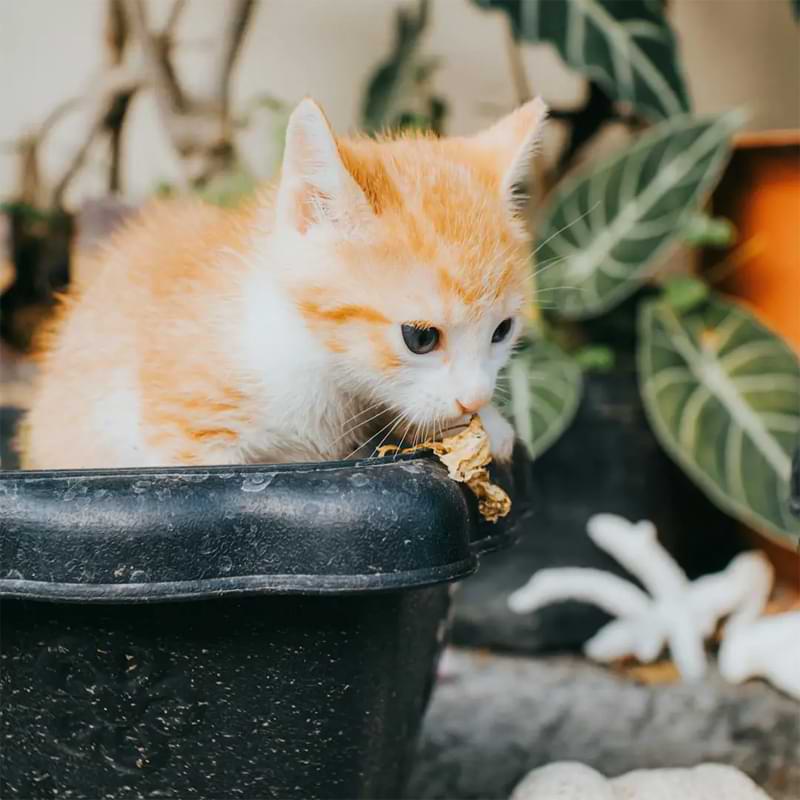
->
xmin=510 ymin=761 xmax=769 ymax=800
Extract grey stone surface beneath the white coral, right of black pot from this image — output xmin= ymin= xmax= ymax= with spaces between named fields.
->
xmin=408 ymin=650 xmax=800 ymax=800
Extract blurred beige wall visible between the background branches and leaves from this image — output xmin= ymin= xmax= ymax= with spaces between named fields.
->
xmin=0 ymin=0 xmax=800 ymax=205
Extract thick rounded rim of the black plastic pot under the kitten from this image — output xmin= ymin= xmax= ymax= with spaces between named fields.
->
xmin=0 ymin=455 xmax=513 ymax=603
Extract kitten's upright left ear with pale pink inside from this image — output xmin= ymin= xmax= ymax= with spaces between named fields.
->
xmin=277 ymin=98 xmax=370 ymax=233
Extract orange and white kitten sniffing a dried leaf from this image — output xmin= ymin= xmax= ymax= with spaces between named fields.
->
xmin=21 ymin=100 xmax=546 ymax=469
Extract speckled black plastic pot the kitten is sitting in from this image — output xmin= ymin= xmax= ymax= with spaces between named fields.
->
xmin=0 ymin=458 xmax=510 ymax=800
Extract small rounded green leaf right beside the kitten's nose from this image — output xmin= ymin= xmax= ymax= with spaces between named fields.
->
xmin=499 ymin=339 xmax=582 ymax=458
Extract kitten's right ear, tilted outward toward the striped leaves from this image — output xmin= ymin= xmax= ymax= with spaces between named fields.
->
xmin=475 ymin=97 xmax=547 ymax=215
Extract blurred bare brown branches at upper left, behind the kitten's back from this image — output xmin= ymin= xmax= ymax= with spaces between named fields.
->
xmin=0 ymin=0 xmax=262 ymax=350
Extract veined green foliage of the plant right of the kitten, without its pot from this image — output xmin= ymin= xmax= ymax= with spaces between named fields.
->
xmin=460 ymin=0 xmax=800 ymax=552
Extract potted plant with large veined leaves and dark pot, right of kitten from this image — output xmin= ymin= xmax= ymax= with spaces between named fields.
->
xmin=454 ymin=0 xmax=800 ymax=650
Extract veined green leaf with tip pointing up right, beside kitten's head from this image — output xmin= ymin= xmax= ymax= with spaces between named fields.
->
xmin=536 ymin=112 xmax=742 ymax=319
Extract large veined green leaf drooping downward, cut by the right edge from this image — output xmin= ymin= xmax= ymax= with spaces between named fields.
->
xmin=639 ymin=296 xmax=800 ymax=536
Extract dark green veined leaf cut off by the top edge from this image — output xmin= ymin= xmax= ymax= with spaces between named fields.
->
xmin=478 ymin=0 xmax=689 ymax=121
